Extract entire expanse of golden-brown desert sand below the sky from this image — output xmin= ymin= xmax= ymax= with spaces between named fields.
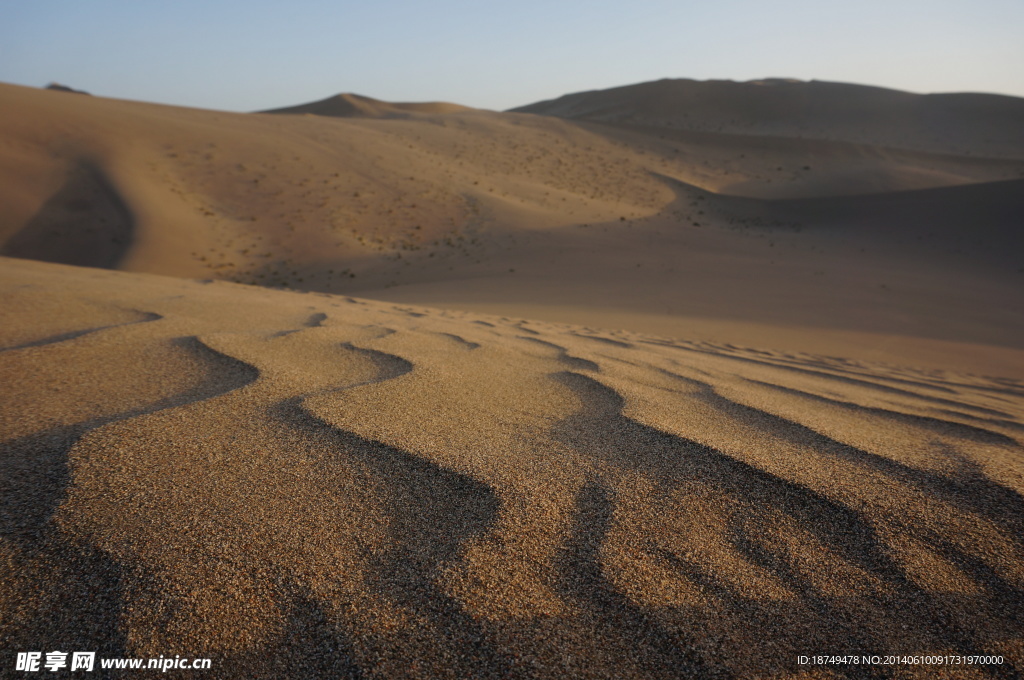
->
xmin=0 ymin=79 xmax=1024 ymax=678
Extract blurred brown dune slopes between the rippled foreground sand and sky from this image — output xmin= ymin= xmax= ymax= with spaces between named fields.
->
xmin=0 ymin=81 xmax=1024 ymax=376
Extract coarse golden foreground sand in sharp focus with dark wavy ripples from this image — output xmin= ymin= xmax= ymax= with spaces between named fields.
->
xmin=0 ymin=274 xmax=1024 ymax=678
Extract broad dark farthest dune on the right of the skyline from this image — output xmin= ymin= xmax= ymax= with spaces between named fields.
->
xmin=512 ymin=78 xmax=1024 ymax=160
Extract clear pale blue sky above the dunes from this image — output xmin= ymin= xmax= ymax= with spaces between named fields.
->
xmin=0 ymin=0 xmax=1024 ymax=111
